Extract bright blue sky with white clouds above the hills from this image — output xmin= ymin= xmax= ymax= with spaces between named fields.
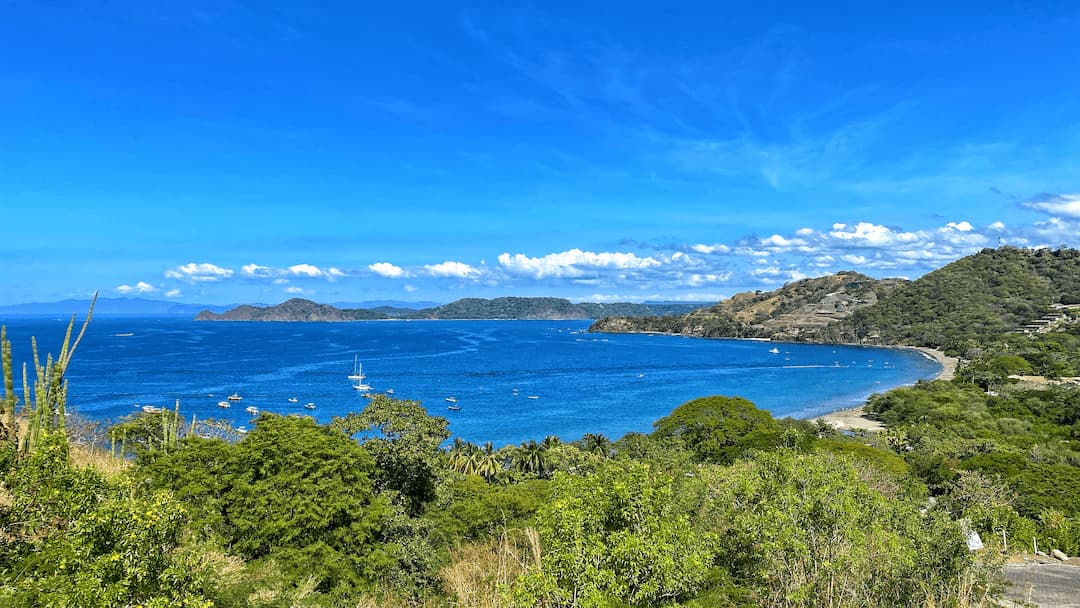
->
xmin=0 ymin=1 xmax=1080 ymax=303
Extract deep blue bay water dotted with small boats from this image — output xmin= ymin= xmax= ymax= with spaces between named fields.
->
xmin=5 ymin=317 xmax=941 ymax=446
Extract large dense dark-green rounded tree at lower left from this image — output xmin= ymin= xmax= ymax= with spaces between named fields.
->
xmin=140 ymin=414 xmax=394 ymax=595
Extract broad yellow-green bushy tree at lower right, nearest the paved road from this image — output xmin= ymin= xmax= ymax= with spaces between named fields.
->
xmin=680 ymin=450 xmax=989 ymax=608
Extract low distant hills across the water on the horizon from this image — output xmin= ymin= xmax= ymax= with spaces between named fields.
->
xmin=195 ymin=297 xmax=700 ymax=322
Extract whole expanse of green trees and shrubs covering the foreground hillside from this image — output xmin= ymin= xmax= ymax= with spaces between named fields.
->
xmin=0 ymin=287 xmax=1080 ymax=608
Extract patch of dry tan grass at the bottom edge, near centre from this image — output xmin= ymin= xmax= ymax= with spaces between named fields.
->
xmin=438 ymin=528 xmax=540 ymax=608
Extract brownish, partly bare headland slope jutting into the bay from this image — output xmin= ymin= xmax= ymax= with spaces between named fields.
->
xmin=591 ymin=272 xmax=906 ymax=340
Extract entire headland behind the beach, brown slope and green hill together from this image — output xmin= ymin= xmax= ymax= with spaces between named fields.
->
xmin=592 ymin=247 xmax=1080 ymax=349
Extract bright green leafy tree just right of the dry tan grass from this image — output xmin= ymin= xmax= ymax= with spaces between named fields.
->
xmin=513 ymin=463 xmax=714 ymax=608
